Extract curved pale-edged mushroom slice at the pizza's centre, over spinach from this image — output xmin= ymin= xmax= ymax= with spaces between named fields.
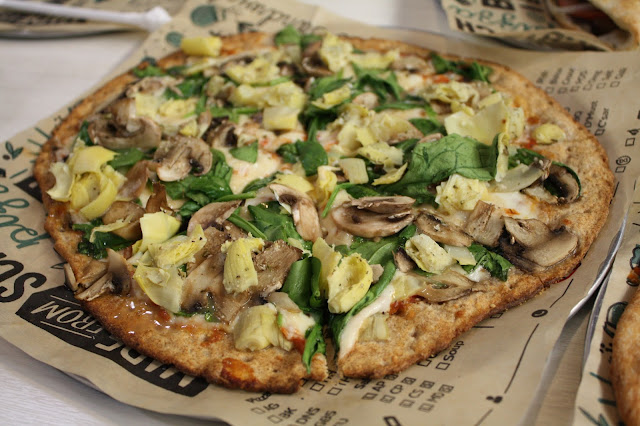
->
xmin=269 ymin=183 xmax=322 ymax=241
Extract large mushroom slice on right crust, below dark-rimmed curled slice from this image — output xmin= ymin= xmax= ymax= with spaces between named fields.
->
xmin=500 ymin=218 xmax=578 ymax=272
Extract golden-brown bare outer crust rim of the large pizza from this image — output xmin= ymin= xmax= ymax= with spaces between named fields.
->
xmin=35 ymin=33 xmax=613 ymax=392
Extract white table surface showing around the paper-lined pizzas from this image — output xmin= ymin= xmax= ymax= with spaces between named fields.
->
xmin=0 ymin=0 xmax=591 ymax=425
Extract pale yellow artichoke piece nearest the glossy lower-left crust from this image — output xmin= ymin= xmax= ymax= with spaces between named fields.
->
xmin=133 ymin=264 xmax=184 ymax=312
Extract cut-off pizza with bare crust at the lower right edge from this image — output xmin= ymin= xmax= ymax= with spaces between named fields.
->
xmin=611 ymin=248 xmax=640 ymax=425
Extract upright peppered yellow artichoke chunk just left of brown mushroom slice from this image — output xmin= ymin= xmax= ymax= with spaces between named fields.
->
xmin=222 ymin=238 xmax=264 ymax=293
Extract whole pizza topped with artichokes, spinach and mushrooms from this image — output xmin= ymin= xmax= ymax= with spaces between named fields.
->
xmin=35 ymin=27 xmax=613 ymax=393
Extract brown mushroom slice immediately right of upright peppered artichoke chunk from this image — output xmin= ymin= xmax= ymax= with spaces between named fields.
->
xmin=253 ymin=240 xmax=302 ymax=297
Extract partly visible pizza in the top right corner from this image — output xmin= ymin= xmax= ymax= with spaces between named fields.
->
xmin=546 ymin=0 xmax=640 ymax=50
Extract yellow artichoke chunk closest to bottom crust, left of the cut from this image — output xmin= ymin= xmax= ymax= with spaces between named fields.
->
xmin=233 ymin=303 xmax=293 ymax=351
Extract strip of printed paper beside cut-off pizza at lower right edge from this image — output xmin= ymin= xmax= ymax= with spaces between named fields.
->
xmin=574 ymin=182 xmax=640 ymax=425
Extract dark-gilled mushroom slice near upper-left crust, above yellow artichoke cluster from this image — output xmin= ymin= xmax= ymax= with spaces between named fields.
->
xmin=89 ymin=98 xmax=162 ymax=149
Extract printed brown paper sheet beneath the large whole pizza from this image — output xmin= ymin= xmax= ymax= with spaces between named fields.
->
xmin=0 ymin=0 xmax=640 ymax=425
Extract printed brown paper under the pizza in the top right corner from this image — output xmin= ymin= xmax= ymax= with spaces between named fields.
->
xmin=441 ymin=0 xmax=636 ymax=51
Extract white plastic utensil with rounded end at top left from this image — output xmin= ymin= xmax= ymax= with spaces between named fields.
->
xmin=0 ymin=0 xmax=171 ymax=32
